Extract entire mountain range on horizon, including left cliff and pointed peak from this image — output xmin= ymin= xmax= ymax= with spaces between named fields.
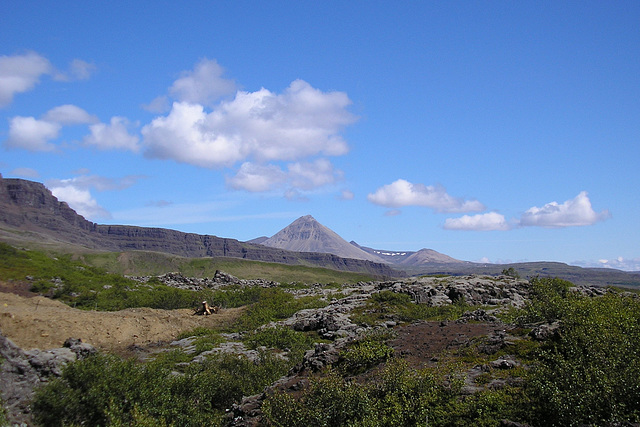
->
xmin=0 ymin=175 xmax=640 ymax=287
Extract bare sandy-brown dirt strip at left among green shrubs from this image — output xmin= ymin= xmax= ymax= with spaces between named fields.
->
xmin=0 ymin=287 xmax=241 ymax=353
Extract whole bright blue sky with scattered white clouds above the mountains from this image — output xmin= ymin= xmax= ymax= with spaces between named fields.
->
xmin=0 ymin=1 xmax=640 ymax=270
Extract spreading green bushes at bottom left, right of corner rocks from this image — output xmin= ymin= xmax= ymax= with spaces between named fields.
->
xmin=32 ymin=354 xmax=289 ymax=426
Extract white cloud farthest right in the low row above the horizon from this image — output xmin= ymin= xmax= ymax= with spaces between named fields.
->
xmin=520 ymin=191 xmax=611 ymax=228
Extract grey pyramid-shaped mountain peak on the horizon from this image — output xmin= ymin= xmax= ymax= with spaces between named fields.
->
xmin=261 ymin=215 xmax=385 ymax=262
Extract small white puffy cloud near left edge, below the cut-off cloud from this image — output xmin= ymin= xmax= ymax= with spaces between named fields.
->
xmin=5 ymin=116 xmax=62 ymax=151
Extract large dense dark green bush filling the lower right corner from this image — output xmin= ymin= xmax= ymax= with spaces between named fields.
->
xmin=529 ymin=290 xmax=640 ymax=425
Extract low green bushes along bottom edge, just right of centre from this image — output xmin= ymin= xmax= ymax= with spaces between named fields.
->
xmin=263 ymin=359 xmax=522 ymax=427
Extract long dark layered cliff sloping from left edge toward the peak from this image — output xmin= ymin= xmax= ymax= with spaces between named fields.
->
xmin=0 ymin=175 xmax=401 ymax=277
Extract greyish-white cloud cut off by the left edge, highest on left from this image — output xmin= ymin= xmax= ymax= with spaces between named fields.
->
xmin=0 ymin=52 xmax=52 ymax=107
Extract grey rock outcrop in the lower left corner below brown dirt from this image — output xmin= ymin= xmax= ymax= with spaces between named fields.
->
xmin=0 ymin=334 xmax=96 ymax=425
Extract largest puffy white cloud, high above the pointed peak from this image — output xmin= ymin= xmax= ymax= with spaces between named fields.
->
xmin=142 ymin=80 xmax=355 ymax=168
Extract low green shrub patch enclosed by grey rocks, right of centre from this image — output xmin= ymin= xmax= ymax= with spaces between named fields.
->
xmin=351 ymin=291 xmax=475 ymax=326
